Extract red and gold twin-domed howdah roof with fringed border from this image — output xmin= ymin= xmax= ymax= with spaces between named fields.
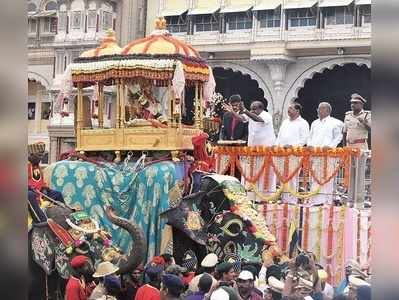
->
xmin=71 ymin=18 xmax=210 ymax=86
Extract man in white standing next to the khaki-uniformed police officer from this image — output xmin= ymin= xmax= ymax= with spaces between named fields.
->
xmin=308 ymin=102 xmax=344 ymax=205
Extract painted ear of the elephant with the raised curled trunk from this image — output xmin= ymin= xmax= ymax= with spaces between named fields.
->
xmin=30 ymin=226 xmax=55 ymax=275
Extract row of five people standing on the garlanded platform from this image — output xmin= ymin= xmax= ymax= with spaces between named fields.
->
xmin=220 ymin=94 xmax=371 ymax=205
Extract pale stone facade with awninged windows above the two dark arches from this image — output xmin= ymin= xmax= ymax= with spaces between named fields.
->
xmin=147 ymin=0 xmax=371 ymax=128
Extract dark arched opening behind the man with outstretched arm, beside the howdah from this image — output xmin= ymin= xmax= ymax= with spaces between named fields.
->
xmin=213 ymin=67 xmax=268 ymax=109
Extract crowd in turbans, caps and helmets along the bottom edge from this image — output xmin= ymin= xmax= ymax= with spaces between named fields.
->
xmin=65 ymin=253 xmax=371 ymax=300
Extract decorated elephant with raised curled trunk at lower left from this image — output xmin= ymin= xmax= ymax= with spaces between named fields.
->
xmin=28 ymin=204 xmax=146 ymax=300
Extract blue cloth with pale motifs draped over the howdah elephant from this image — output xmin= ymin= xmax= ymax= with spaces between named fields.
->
xmin=50 ymin=161 xmax=182 ymax=260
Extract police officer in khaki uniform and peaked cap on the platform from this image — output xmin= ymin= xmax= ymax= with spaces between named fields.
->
xmin=343 ymin=94 xmax=371 ymax=150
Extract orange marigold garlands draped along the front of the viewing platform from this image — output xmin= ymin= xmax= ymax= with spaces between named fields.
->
xmin=214 ymin=146 xmax=360 ymax=200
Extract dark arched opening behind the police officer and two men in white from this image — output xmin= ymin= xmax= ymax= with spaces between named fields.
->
xmin=295 ymin=63 xmax=371 ymax=123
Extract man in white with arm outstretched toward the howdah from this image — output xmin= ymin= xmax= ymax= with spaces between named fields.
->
xmin=225 ymin=101 xmax=276 ymax=194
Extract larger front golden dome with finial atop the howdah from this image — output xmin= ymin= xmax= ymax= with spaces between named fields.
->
xmin=122 ymin=18 xmax=202 ymax=60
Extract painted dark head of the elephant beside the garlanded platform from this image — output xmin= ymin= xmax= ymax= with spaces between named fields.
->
xmin=162 ymin=174 xmax=275 ymax=268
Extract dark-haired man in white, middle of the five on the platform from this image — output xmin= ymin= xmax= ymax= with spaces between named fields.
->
xmin=276 ymin=102 xmax=309 ymax=204
